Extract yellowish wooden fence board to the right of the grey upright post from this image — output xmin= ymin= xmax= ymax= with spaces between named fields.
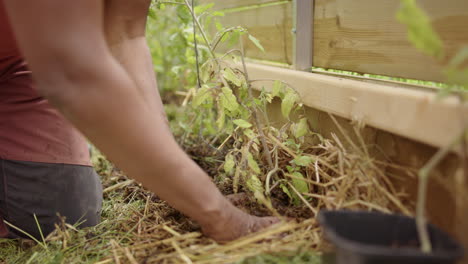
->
xmin=313 ymin=0 xmax=468 ymax=81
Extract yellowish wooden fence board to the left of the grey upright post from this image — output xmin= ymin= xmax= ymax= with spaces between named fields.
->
xmin=211 ymin=2 xmax=293 ymax=64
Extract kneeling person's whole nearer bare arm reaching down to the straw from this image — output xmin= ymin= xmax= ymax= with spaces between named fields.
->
xmin=4 ymin=0 xmax=273 ymax=240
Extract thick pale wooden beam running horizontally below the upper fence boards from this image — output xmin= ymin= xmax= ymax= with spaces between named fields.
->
xmin=247 ymin=63 xmax=468 ymax=147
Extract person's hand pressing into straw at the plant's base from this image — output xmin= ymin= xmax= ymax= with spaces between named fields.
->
xmin=202 ymin=195 xmax=280 ymax=243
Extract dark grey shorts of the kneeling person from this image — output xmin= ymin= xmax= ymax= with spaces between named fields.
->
xmin=0 ymin=159 xmax=102 ymax=238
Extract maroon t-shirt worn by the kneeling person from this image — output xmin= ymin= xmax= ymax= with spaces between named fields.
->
xmin=0 ymin=0 xmax=90 ymax=165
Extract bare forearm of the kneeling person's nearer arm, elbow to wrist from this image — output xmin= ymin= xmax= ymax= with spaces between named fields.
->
xmin=50 ymin=55 xmax=229 ymax=225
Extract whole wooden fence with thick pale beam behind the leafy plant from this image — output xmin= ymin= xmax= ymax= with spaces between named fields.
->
xmin=201 ymin=0 xmax=468 ymax=260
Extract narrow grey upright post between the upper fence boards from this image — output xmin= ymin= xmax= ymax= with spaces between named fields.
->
xmin=293 ymin=0 xmax=314 ymax=71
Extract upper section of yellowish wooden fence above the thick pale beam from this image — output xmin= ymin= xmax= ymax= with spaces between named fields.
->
xmin=206 ymin=0 xmax=468 ymax=82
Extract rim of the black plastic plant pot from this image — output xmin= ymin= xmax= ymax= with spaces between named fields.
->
xmin=318 ymin=210 xmax=463 ymax=261
